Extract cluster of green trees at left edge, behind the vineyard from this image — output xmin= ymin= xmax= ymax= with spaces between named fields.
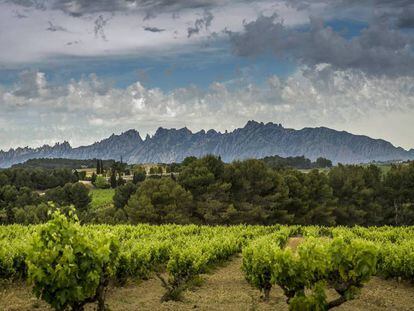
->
xmin=0 ymin=168 xmax=91 ymax=224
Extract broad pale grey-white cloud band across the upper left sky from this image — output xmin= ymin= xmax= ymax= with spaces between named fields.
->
xmin=0 ymin=0 xmax=316 ymax=67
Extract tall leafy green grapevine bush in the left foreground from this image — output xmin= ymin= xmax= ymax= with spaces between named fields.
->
xmin=27 ymin=211 xmax=119 ymax=311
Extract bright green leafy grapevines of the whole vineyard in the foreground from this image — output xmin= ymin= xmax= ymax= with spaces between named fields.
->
xmin=0 ymin=212 xmax=414 ymax=310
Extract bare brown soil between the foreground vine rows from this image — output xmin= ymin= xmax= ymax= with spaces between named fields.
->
xmin=0 ymin=238 xmax=414 ymax=311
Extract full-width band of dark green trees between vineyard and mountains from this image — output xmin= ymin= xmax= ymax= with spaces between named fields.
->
xmin=0 ymin=156 xmax=414 ymax=226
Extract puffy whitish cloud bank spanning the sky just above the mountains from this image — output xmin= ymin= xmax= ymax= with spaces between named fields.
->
xmin=0 ymin=64 xmax=414 ymax=148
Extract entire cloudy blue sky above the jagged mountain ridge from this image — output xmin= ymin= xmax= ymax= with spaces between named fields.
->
xmin=0 ymin=0 xmax=414 ymax=150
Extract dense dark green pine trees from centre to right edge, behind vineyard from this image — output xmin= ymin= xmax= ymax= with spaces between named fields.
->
xmin=114 ymin=156 xmax=414 ymax=226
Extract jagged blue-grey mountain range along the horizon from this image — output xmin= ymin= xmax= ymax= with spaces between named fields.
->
xmin=0 ymin=121 xmax=414 ymax=167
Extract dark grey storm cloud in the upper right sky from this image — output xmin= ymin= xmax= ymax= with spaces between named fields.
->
xmin=227 ymin=15 xmax=414 ymax=75
